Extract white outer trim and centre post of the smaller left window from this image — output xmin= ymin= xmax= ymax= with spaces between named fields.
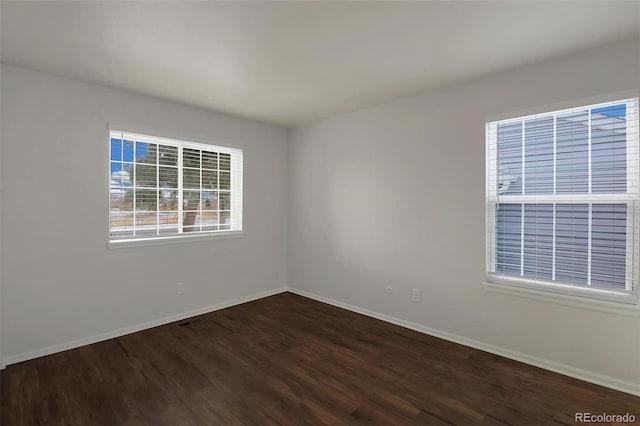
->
xmin=106 ymin=125 xmax=245 ymax=245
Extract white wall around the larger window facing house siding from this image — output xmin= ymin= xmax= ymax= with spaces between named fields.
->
xmin=289 ymin=38 xmax=640 ymax=392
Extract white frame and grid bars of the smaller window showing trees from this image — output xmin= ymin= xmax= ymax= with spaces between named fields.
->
xmin=106 ymin=126 xmax=244 ymax=249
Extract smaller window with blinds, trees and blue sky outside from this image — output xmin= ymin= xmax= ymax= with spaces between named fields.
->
xmin=109 ymin=131 xmax=242 ymax=243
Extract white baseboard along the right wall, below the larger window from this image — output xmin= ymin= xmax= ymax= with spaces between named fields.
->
xmin=289 ymin=287 xmax=640 ymax=396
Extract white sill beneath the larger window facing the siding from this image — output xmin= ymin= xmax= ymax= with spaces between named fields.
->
xmin=482 ymin=281 xmax=640 ymax=317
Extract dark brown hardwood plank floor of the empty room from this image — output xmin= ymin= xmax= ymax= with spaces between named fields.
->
xmin=1 ymin=293 xmax=640 ymax=426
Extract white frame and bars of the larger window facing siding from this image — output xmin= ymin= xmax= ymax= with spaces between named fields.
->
xmin=485 ymin=96 xmax=640 ymax=306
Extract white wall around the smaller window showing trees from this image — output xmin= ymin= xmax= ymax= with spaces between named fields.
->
xmin=1 ymin=65 xmax=288 ymax=360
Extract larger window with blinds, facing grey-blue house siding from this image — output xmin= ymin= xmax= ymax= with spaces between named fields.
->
xmin=486 ymin=98 xmax=639 ymax=304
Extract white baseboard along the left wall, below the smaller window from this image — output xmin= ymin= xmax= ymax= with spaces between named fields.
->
xmin=0 ymin=287 xmax=287 ymax=368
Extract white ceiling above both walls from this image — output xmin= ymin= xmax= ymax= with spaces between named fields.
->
xmin=1 ymin=1 xmax=640 ymax=126
